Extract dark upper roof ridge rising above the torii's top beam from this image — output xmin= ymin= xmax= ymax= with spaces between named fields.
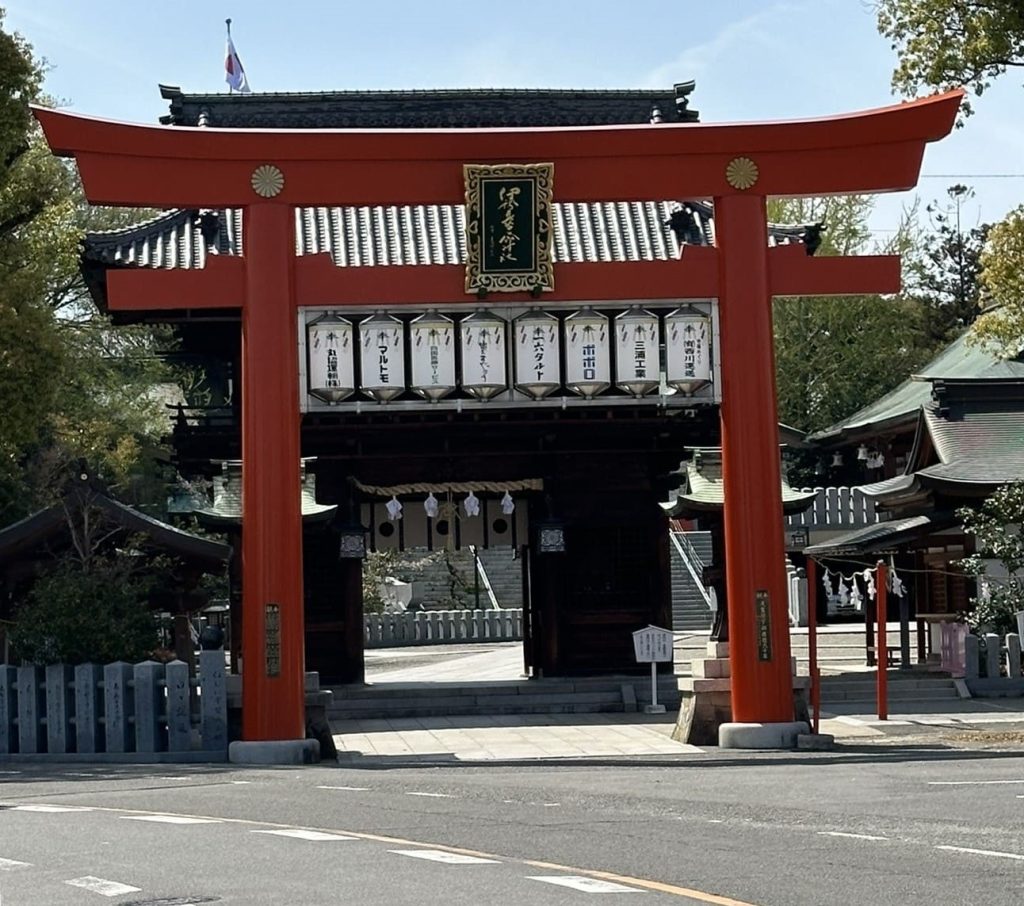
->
xmin=160 ymin=82 xmax=698 ymax=129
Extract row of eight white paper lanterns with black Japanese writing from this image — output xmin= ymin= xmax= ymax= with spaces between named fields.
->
xmin=306 ymin=306 xmax=712 ymax=403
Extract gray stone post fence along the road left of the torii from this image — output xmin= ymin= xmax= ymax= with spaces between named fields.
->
xmin=0 ymin=650 xmax=227 ymax=761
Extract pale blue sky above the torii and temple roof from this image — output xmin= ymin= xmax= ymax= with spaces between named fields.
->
xmin=8 ymin=0 xmax=1024 ymax=239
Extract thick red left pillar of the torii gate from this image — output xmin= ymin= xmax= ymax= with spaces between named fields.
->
xmin=242 ymin=203 xmax=306 ymax=740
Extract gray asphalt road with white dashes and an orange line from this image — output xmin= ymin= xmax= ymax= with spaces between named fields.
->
xmin=0 ymin=748 xmax=1024 ymax=906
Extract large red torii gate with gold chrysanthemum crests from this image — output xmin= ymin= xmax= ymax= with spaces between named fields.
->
xmin=35 ymin=91 xmax=963 ymax=740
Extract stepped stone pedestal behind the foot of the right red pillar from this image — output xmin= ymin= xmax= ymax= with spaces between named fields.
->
xmin=672 ymin=642 xmax=811 ymax=748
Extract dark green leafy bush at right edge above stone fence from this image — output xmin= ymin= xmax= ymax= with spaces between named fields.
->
xmin=957 ymin=482 xmax=1024 ymax=636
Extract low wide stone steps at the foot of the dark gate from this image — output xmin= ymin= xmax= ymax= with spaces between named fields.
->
xmin=327 ymin=676 xmax=680 ymax=724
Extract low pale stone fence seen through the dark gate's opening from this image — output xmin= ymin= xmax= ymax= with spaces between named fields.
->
xmin=362 ymin=608 xmax=522 ymax=648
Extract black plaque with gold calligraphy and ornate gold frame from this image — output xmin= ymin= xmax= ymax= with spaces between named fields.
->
xmin=463 ymin=164 xmax=555 ymax=294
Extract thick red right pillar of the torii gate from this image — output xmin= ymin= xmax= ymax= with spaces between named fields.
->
xmin=715 ymin=195 xmax=793 ymax=723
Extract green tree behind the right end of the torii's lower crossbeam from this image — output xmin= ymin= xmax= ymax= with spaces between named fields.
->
xmin=769 ymin=197 xmax=935 ymax=432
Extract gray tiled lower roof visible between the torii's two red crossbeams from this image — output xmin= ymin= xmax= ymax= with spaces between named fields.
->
xmin=85 ymin=202 xmax=804 ymax=268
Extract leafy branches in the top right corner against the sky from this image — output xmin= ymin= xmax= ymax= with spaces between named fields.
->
xmin=876 ymin=0 xmax=1024 ymax=116
